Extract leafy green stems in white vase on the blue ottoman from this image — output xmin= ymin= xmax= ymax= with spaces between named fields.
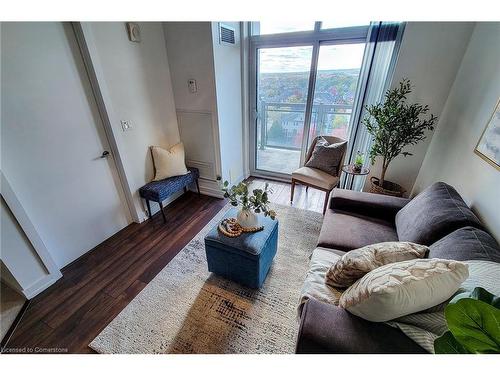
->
xmin=222 ymin=181 xmax=276 ymax=228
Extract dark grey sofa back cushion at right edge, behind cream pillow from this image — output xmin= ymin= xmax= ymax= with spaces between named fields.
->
xmin=429 ymin=227 xmax=500 ymax=263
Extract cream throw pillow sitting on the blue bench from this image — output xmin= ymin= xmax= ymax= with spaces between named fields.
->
xmin=151 ymin=142 xmax=189 ymax=181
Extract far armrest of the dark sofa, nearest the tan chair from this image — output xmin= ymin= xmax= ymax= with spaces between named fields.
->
xmin=330 ymin=189 xmax=410 ymax=221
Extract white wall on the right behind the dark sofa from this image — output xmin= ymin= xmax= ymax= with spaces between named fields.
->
xmin=414 ymin=22 xmax=500 ymax=241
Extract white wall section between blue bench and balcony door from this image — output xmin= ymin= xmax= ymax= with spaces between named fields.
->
xmin=164 ymin=22 xmax=244 ymax=191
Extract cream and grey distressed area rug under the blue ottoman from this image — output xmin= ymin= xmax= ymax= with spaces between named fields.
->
xmin=89 ymin=205 xmax=323 ymax=354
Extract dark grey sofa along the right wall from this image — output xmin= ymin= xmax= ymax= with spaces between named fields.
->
xmin=296 ymin=182 xmax=500 ymax=353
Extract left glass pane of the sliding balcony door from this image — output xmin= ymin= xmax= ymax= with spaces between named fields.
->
xmin=255 ymin=46 xmax=313 ymax=174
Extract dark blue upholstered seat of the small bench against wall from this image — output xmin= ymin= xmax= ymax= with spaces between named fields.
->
xmin=139 ymin=168 xmax=200 ymax=202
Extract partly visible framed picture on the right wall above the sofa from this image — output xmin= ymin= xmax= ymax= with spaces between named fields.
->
xmin=474 ymin=98 xmax=500 ymax=170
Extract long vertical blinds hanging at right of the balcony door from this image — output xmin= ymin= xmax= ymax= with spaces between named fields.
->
xmin=341 ymin=22 xmax=404 ymax=191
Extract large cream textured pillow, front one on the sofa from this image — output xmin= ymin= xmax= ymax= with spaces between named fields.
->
xmin=339 ymin=259 xmax=469 ymax=322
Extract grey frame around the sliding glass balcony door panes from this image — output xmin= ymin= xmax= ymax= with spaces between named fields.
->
xmin=248 ymin=22 xmax=371 ymax=181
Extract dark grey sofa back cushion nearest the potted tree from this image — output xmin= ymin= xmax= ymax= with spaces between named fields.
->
xmin=396 ymin=182 xmax=483 ymax=246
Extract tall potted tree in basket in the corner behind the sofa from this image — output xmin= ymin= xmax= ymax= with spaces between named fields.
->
xmin=362 ymin=79 xmax=437 ymax=196
